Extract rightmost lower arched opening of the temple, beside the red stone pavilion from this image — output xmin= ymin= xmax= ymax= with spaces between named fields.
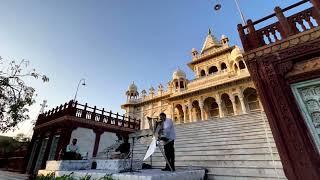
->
xmin=243 ymin=87 xmax=260 ymax=111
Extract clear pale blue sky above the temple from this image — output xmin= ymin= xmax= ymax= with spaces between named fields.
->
xmin=0 ymin=0 xmax=310 ymax=135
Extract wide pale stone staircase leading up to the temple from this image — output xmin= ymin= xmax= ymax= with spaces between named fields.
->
xmin=134 ymin=111 xmax=286 ymax=180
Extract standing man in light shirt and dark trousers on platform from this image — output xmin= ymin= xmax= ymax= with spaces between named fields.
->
xmin=159 ymin=112 xmax=176 ymax=171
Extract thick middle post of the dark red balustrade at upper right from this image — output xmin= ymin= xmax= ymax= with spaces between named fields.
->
xmin=274 ymin=6 xmax=293 ymax=39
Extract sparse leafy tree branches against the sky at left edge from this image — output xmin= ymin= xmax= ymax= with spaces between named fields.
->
xmin=0 ymin=57 xmax=49 ymax=132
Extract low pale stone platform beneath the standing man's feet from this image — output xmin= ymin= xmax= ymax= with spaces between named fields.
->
xmin=38 ymin=168 xmax=205 ymax=180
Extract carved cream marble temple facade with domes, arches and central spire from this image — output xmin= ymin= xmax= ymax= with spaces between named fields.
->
xmin=121 ymin=30 xmax=262 ymax=129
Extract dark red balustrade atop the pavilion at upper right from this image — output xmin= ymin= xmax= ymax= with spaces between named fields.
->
xmin=238 ymin=0 xmax=320 ymax=52
